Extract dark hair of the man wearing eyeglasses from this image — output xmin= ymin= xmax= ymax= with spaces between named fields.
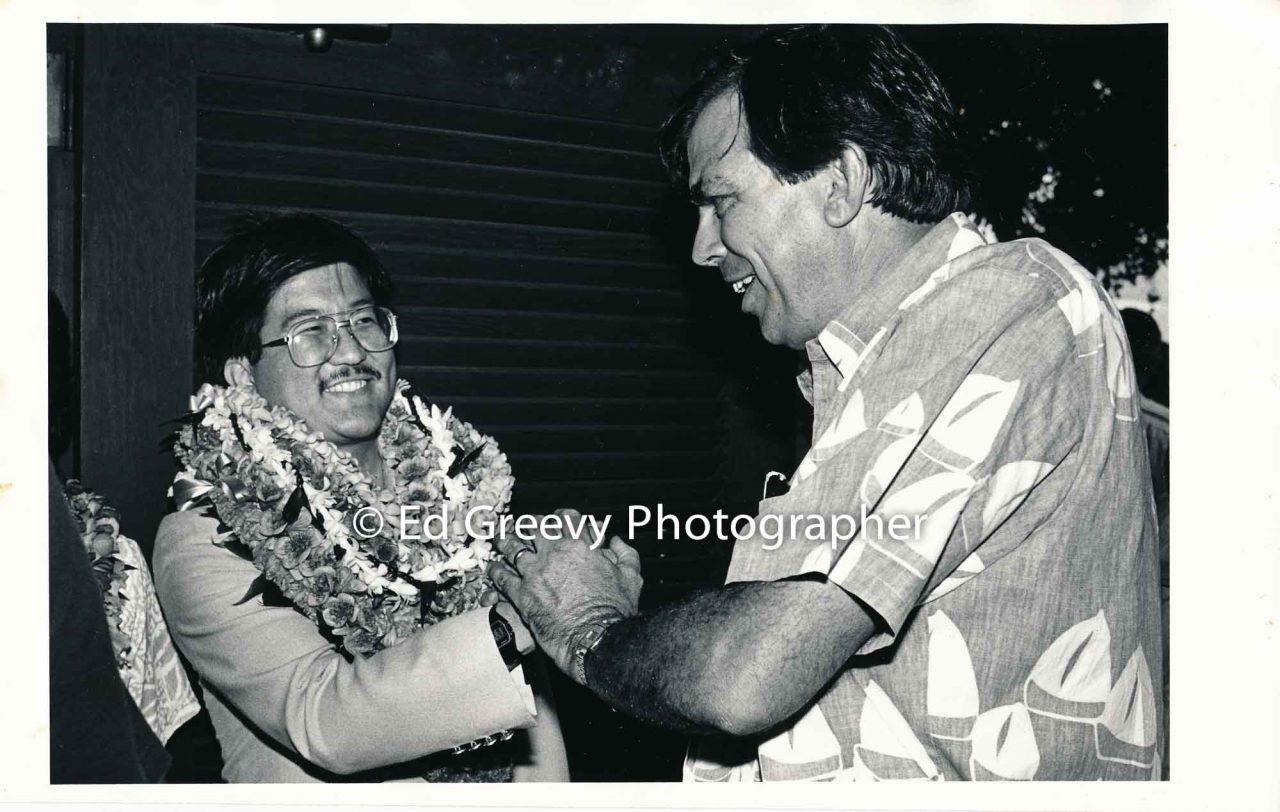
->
xmin=196 ymin=213 xmax=393 ymax=383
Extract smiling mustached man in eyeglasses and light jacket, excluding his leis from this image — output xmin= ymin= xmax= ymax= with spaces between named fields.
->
xmin=155 ymin=214 xmax=568 ymax=783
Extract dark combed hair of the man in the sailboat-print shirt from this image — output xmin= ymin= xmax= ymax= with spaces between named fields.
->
xmin=662 ymin=26 xmax=969 ymax=223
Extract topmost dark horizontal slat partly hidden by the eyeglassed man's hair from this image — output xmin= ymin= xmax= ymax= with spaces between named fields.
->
xmin=196 ymin=201 xmax=663 ymax=261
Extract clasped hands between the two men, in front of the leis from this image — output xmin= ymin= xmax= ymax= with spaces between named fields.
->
xmin=489 ymin=510 xmax=644 ymax=676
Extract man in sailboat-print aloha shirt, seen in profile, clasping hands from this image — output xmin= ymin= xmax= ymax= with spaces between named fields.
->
xmin=483 ymin=28 xmax=1165 ymax=781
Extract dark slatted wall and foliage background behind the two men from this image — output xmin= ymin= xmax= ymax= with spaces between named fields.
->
xmin=47 ymin=26 xmax=1167 ymax=780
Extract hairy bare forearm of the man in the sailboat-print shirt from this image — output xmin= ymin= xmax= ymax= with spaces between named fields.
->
xmin=586 ymin=581 xmax=874 ymax=735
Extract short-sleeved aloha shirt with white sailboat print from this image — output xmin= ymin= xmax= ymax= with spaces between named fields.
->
xmin=685 ymin=214 xmax=1165 ymax=781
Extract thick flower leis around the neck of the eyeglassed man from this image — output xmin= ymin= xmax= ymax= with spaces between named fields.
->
xmin=170 ymin=380 xmax=515 ymax=656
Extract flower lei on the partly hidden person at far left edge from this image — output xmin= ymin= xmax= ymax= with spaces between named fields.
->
xmin=63 ymin=479 xmax=133 ymax=669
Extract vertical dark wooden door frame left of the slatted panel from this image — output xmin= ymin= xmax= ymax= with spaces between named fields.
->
xmin=77 ymin=24 xmax=196 ymax=552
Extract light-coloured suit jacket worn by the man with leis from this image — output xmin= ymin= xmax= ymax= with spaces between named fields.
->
xmin=154 ymin=511 xmax=568 ymax=783
